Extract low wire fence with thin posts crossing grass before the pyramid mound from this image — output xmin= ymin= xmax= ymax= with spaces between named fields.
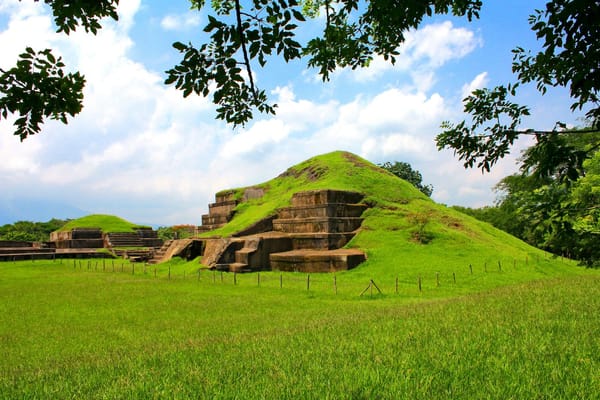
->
xmin=8 ymin=253 xmax=572 ymax=297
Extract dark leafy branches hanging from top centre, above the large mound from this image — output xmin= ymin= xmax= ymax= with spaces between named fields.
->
xmin=166 ymin=0 xmax=482 ymax=125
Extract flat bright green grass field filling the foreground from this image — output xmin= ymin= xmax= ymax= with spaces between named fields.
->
xmin=0 ymin=255 xmax=600 ymax=399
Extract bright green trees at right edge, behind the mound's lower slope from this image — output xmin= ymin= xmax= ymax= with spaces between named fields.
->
xmin=455 ymin=131 xmax=600 ymax=267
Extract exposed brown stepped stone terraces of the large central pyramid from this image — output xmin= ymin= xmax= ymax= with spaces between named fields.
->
xmin=162 ymin=188 xmax=367 ymax=272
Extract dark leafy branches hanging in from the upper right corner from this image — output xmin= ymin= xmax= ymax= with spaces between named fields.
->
xmin=436 ymin=0 xmax=600 ymax=182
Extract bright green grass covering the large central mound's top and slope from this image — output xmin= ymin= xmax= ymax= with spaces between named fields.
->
xmin=199 ymin=152 xmax=574 ymax=288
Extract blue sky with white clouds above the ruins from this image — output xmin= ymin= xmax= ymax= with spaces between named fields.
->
xmin=0 ymin=0 xmax=581 ymax=225
